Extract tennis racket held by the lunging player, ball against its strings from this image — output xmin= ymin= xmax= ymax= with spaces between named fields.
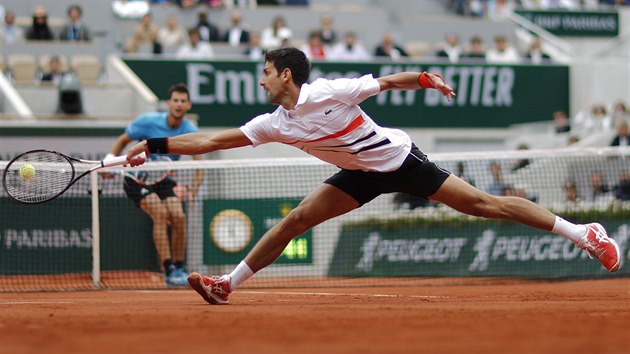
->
xmin=2 ymin=150 xmax=146 ymax=204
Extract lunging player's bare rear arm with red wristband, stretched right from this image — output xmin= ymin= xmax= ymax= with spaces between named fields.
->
xmin=377 ymin=71 xmax=455 ymax=101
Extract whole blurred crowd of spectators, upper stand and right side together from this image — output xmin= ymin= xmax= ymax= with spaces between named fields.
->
xmin=0 ymin=0 xmax=630 ymax=213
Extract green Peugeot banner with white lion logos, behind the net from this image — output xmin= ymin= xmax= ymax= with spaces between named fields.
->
xmin=329 ymin=220 xmax=630 ymax=277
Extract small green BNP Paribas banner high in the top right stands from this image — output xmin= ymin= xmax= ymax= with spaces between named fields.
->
xmin=515 ymin=10 xmax=619 ymax=37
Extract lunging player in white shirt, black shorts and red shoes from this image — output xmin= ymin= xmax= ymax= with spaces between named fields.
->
xmin=127 ymin=48 xmax=620 ymax=304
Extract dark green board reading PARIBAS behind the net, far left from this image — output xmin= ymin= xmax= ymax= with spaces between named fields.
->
xmin=0 ymin=197 xmax=160 ymax=275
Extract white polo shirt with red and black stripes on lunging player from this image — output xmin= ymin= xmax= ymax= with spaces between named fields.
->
xmin=240 ymin=75 xmax=411 ymax=172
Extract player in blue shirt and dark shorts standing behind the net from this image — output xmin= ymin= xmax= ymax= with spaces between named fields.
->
xmin=108 ymin=84 xmax=203 ymax=287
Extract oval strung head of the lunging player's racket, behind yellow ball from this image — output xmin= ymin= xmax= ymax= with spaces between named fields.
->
xmin=5 ymin=151 xmax=74 ymax=203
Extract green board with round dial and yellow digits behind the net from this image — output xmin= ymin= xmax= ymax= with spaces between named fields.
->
xmin=203 ymin=198 xmax=313 ymax=265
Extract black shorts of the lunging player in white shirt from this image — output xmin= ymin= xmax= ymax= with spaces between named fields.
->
xmin=324 ymin=145 xmax=451 ymax=204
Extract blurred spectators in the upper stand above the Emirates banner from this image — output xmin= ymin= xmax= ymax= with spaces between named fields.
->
xmin=0 ymin=1 xmax=572 ymax=64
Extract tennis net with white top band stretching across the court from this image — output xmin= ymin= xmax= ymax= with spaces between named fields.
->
xmin=0 ymin=148 xmax=630 ymax=291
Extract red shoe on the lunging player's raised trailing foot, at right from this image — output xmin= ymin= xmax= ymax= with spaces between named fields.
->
xmin=577 ymin=223 xmax=621 ymax=272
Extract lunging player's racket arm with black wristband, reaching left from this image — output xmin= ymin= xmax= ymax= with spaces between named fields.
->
xmin=127 ymin=128 xmax=252 ymax=166
